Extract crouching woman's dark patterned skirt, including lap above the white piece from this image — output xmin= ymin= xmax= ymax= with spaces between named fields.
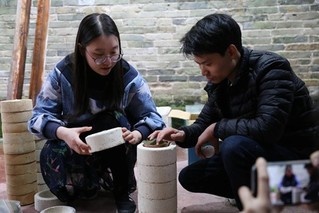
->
xmin=40 ymin=111 xmax=136 ymax=201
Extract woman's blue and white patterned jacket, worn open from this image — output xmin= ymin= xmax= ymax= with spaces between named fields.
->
xmin=28 ymin=55 xmax=165 ymax=140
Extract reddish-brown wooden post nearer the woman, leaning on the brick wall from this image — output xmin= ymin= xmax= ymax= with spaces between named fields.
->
xmin=29 ymin=0 xmax=50 ymax=104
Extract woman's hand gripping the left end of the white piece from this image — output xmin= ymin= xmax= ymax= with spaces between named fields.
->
xmin=56 ymin=126 xmax=92 ymax=155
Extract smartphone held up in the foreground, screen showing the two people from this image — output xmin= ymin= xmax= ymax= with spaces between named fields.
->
xmin=251 ymin=160 xmax=319 ymax=206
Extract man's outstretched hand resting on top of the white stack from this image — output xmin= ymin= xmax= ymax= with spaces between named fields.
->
xmin=148 ymin=127 xmax=185 ymax=142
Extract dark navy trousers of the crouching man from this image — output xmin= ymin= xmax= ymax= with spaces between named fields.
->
xmin=179 ymin=136 xmax=302 ymax=210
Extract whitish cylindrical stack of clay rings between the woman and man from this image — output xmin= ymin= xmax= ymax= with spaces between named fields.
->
xmin=137 ymin=143 xmax=177 ymax=213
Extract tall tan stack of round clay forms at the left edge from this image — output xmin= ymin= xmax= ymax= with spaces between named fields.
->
xmin=1 ymin=99 xmax=37 ymax=205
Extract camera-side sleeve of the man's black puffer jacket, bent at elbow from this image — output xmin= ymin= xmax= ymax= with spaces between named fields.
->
xmin=214 ymin=57 xmax=302 ymax=144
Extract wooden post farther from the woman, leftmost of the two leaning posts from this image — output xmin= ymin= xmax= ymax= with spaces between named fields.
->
xmin=7 ymin=0 xmax=31 ymax=100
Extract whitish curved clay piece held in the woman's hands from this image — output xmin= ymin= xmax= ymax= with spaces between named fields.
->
xmin=85 ymin=127 xmax=125 ymax=152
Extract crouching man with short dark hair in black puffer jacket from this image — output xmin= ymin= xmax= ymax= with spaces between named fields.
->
xmin=149 ymin=14 xmax=318 ymax=210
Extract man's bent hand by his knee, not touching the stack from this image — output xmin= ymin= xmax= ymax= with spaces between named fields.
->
xmin=195 ymin=123 xmax=219 ymax=158
